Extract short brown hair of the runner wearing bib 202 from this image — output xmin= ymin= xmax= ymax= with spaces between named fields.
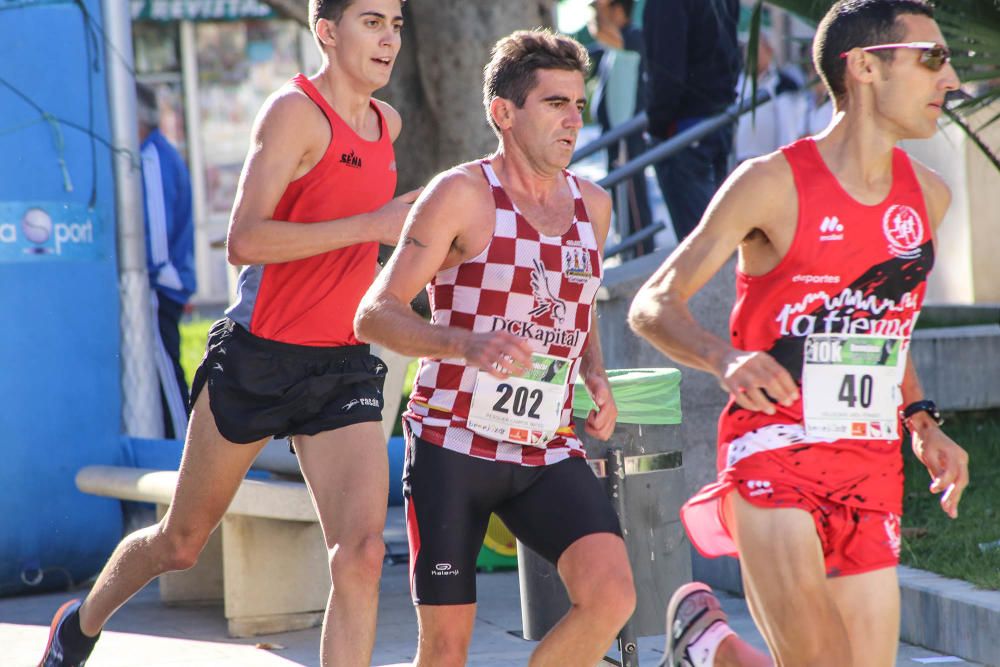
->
xmin=483 ymin=28 xmax=590 ymax=134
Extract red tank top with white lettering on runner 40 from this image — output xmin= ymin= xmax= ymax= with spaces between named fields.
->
xmin=719 ymin=138 xmax=934 ymax=469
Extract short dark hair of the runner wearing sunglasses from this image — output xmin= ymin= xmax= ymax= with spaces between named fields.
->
xmin=813 ymin=0 xmax=934 ymax=101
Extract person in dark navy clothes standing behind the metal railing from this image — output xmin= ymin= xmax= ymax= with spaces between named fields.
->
xmin=643 ymin=0 xmax=742 ymax=241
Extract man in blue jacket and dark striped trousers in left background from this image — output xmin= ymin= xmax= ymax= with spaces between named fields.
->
xmin=136 ymin=83 xmax=197 ymax=438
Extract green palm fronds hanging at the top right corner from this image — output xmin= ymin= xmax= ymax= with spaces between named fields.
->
xmin=747 ymin=0 xmax=1000 ymax=171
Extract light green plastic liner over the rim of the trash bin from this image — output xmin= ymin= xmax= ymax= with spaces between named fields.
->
xmin=573 ymin=368 xmax=681 ymax=424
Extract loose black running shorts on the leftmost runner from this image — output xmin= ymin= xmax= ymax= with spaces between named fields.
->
xmin=191 ymin=318 xmax=386 ymax=443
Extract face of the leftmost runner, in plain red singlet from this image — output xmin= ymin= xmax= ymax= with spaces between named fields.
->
xmin=317 ymin=0 xmax=403 ymax=91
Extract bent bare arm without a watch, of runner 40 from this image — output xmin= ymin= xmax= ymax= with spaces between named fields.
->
xmin=628 ymin=153 xmax=798 ymax=414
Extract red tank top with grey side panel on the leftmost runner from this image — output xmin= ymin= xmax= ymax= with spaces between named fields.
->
xmin=226 ymin=74 xmax=396 ymax=347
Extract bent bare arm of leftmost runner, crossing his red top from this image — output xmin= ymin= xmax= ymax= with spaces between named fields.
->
xmin=226 ymin=89 xmax=419 ymax=264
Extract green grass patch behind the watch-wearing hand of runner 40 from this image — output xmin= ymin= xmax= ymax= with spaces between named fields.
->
xmin=900 ymin=410 xmax=1000 ymax=590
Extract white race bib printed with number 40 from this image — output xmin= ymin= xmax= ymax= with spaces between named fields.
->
xmin=802 ymin=334 xmax=909 ymax=440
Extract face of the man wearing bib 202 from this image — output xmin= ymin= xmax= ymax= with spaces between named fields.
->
xmin=510 ymin=69 xmax=587 ymax=169
